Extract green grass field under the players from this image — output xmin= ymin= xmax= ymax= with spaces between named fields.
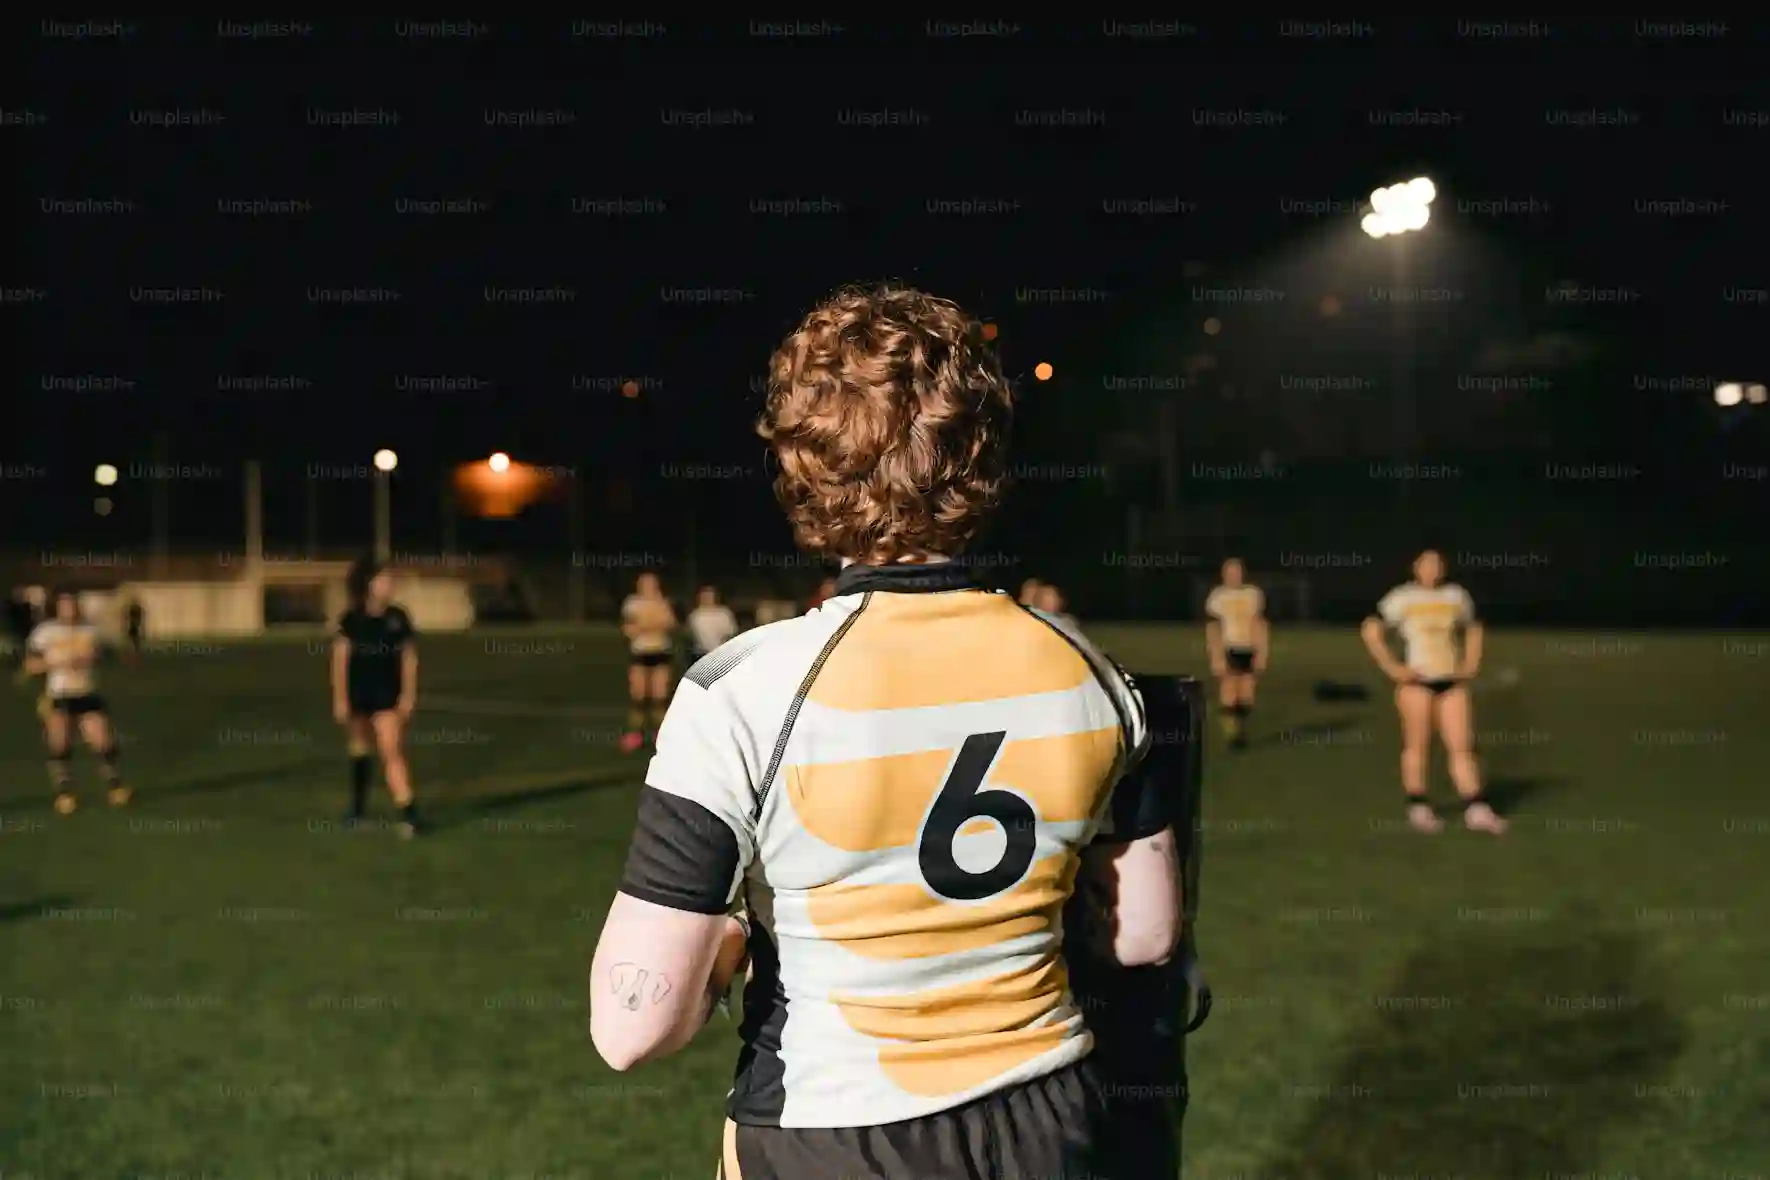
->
xmin=0 ymin=626 xmax=1770 ymax=1180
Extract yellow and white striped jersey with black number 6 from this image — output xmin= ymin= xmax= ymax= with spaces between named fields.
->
xmin=621 ymin=564 xmax=1152 ymax=1127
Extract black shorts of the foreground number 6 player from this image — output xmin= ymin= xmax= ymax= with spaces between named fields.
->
xmin=719 ymin=1061 xmax=1146 ymax=1180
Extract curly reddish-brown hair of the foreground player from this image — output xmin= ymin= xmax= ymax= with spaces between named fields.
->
xmin=756 ymin=287 xmax=1014 ymax=564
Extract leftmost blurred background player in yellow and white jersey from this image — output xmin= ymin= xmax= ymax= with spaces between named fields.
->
xmin=25 ymin=591 xmax=129 ymax=816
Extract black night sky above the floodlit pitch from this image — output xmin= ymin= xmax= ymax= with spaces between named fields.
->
xmin=13 ymin=18 xmax=1770 ymax=555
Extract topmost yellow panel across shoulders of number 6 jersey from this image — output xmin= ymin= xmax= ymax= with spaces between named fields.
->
xmin=809 ymin=591 xmax=1092 ymax=713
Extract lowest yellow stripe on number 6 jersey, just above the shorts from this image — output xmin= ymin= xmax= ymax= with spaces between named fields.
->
xmin=830 ymin=955 xmax=1069 ymax=1097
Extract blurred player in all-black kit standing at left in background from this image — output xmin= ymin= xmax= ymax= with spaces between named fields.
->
xmin=331 ymin=557 xmax=419 ymax=840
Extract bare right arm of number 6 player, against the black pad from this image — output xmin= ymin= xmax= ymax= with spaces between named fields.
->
xmin=1080 ymin=828 xmax=1186 ymax=968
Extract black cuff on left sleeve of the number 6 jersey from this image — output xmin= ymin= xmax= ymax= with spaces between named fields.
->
xmin=621 ymin=787 xmax=742 ymax=913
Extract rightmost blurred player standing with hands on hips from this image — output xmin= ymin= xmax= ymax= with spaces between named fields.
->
xmin=1363 ymin=548 xmax=1506 ymax=835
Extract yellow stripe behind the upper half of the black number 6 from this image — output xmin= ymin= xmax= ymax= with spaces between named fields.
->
xmin=786 ymin=725 xmax=1120 ymax=853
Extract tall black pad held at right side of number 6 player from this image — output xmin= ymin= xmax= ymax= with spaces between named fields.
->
xmin=1064 ymin=676 xmax=1211 ymax=1180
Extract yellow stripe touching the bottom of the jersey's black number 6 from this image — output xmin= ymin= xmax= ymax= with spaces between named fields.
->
xmin=805 ymin=853 xmax=1081 ymax=959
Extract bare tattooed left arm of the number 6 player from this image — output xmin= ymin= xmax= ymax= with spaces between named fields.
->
xmin=589 ymin=893 xmax=743 ymax=1070
